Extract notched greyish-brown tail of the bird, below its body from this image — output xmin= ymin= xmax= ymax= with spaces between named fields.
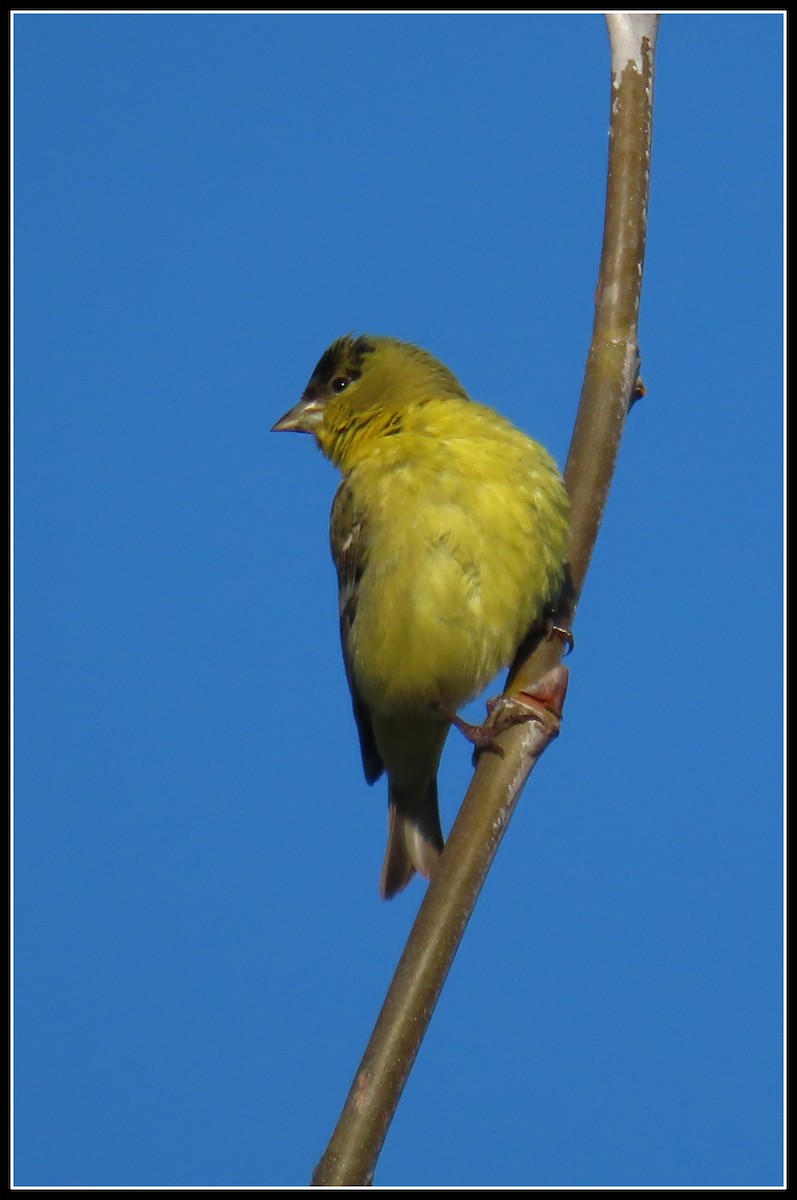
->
xmin=379 ymin=779 xmax=443 ymax=900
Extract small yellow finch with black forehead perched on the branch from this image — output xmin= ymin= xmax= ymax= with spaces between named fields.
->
xmin=272 ymin=334 xmax=569 ymax=899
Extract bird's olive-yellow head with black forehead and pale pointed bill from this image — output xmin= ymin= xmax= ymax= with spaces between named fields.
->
xmin=272 ymin=334 xmax=468 ymax=466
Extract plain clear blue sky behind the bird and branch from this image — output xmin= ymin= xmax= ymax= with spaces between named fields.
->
xmin=13 ymin=13 xmax=783 ymax=1187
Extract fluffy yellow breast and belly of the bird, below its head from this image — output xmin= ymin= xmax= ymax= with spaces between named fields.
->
xmin=346 ymin=400 xmax=568 ymax=714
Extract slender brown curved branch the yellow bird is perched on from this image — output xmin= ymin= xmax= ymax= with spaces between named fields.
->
xmin=312 ymin=13 xmax=659 ymax=1187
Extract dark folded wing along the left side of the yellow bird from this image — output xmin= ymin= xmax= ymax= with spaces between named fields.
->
xmin=329 ymin=481 xmax=384 ymax=784
